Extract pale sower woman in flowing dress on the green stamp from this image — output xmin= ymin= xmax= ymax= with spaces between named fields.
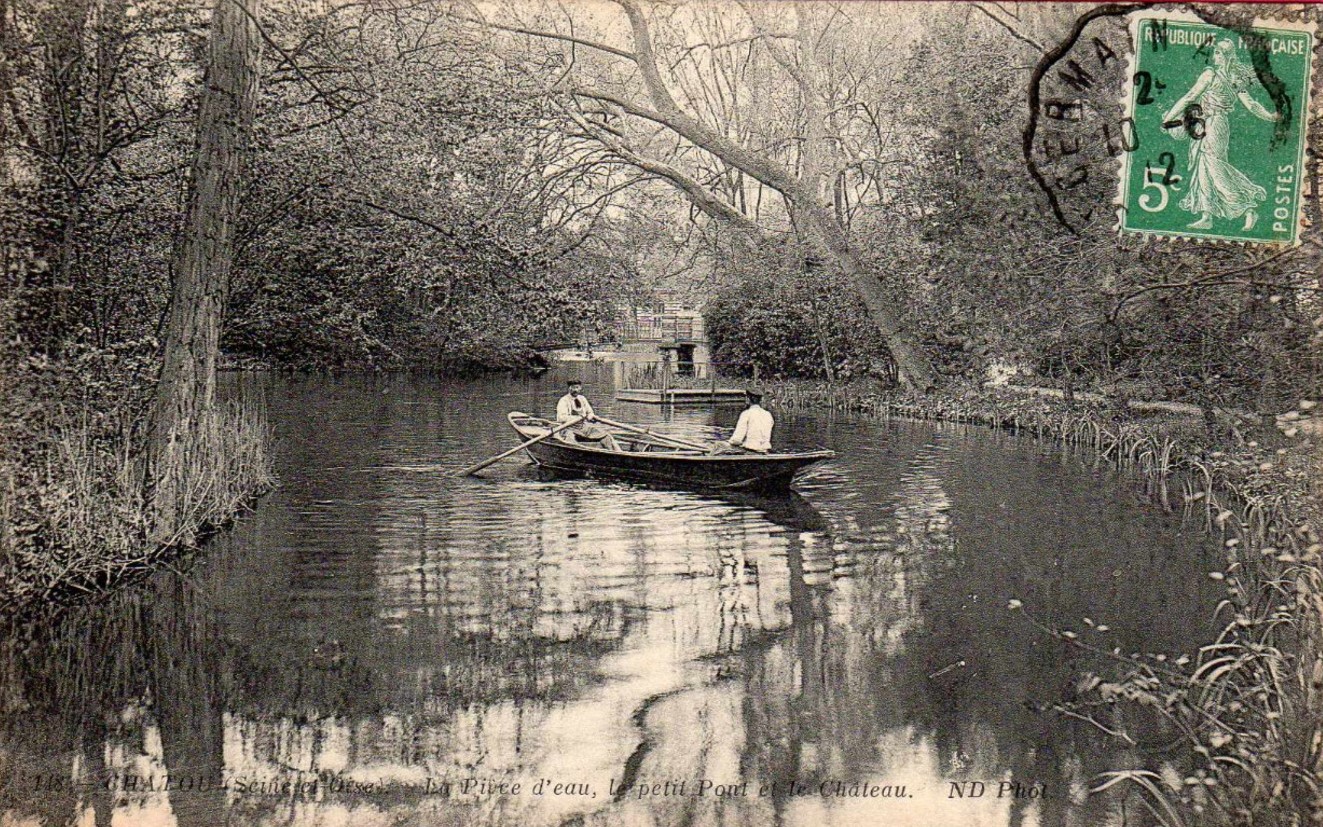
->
xmin=1164 ymin=40 xmax=1281 ymax=230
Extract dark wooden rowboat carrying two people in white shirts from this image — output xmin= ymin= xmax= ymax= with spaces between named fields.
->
xmin=508 ymin=412 xmax=836 ymax=491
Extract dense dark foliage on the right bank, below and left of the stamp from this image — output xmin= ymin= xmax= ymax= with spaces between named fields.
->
xmin=877 ymin=9 xmax=1320 ymax=410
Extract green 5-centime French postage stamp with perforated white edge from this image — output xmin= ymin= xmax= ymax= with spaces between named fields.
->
xmin=1119 ymin=12 xmax=1314 ymax=243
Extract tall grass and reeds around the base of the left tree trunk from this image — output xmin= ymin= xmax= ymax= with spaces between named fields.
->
xmin=0 ymin=402 xmax=274 ymax=614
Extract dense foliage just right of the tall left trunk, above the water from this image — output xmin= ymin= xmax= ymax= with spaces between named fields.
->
xmin=225 ymin=9 xmax=624 ymax=370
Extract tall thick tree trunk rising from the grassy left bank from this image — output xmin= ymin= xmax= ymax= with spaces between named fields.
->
xmin=148 ymin=0 xmax=261 ymax=543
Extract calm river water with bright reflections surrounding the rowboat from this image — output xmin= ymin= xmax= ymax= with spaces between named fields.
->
xmin=0 ymin=367 xmax=1220 ymax=827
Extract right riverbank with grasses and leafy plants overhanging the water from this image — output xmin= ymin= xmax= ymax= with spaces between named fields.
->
xmin=769 ymin=381 xmax=1323 ymax=826
